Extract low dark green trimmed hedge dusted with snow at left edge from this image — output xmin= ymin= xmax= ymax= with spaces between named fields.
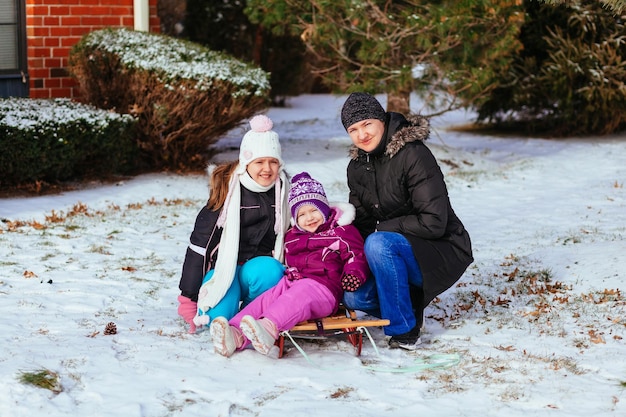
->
xmin=0 ymin=98 xmax=137 ymax=187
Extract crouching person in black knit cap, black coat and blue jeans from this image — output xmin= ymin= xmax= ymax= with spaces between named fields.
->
xmin=341 ymin=93 xmax=473 ymax=350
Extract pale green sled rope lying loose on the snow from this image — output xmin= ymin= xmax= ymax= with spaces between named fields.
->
xmin=282 ymin=327 xmax=461 ymax=373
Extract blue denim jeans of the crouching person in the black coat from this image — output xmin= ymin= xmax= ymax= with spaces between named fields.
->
xmin=343 ymin=232 xmax=422 ymax=336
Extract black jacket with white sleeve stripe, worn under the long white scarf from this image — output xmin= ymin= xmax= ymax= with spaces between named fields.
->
xmin=178 ymin=187 xmax=276 ymax=301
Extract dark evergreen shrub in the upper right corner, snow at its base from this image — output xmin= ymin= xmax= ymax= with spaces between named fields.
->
xmin=479 ymin=0 xmax=626 ymax=136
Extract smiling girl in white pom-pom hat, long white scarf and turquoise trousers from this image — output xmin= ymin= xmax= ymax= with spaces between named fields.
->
xmin=178 ymin=115 xmax=290 ymax=333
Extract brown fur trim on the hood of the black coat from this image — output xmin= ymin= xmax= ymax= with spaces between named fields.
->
xmin=349 ymin=112 xmax=430 ymax=159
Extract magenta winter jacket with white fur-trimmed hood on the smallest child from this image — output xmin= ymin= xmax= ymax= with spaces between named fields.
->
xmin=285 ymin=203 xmax=370 ymax=309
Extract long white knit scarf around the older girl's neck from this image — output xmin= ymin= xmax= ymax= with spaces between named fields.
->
xmin=194 ymin=166 xmax=290 ymax=326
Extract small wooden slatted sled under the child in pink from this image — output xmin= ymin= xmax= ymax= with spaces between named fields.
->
xmin=276 ymin=307 xmax=389 ymax=358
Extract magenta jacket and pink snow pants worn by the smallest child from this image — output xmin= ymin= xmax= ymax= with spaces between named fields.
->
xmin=229 ymin=204 xmax=370 ymax=332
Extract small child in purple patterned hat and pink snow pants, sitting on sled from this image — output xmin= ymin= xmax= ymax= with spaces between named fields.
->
xmin=210 ymin=172 xmax=369 ymax=357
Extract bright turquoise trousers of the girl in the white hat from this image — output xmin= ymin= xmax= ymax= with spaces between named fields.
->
xmin=202 ymin=256 xmax=285 ymax=320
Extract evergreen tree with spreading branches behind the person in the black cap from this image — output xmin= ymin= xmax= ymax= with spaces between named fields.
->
xmin=246 ymin=0 xmax=523 ymax=113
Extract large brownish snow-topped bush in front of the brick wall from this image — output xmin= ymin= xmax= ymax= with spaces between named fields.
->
xmin=69 ymin=29 xmax=270 ymax=171
